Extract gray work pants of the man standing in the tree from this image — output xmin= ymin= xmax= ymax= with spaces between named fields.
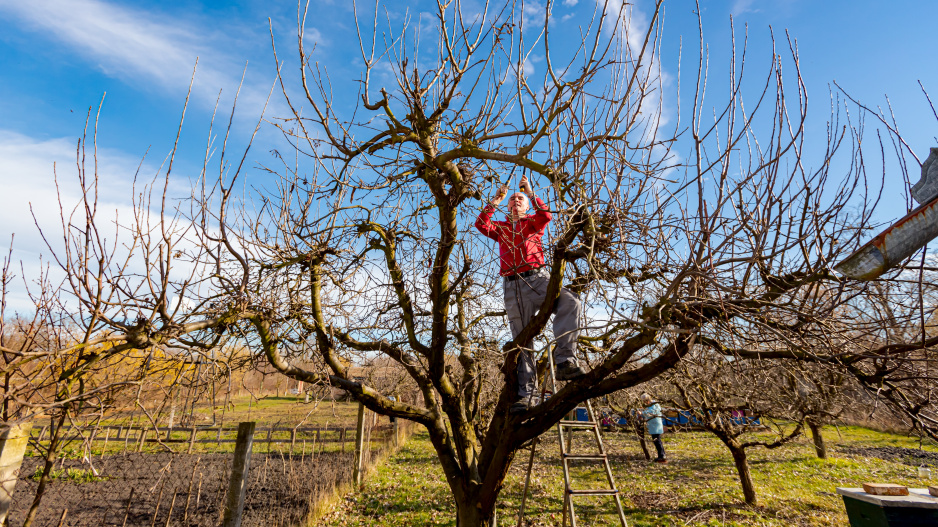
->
xmin=502 ymin=267 xmax=583 ymax=397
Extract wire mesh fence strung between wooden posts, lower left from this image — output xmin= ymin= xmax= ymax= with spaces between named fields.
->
xmin=9 ymin=412 xmax=412 ymax=527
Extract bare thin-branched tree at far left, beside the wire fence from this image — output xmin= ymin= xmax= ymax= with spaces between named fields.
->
xmin=0 ymin=100 xmax=247 ymax=526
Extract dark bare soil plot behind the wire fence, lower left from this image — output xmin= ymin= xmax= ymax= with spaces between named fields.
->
xmin=11 ymin=452 xmax=353 ymax=527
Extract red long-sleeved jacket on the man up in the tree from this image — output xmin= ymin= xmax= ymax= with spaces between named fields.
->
xmin=476 ymin=196 xmax=551 ymax=276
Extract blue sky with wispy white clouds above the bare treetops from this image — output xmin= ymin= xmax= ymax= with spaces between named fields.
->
xmin=0 ymin=0 xmax=938 ymax=312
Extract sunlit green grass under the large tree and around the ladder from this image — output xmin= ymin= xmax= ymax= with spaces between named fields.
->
xmin=322 ymin=427 xmax=938 ymax=527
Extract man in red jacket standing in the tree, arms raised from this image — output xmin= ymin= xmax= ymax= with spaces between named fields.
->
xmin=475 ymin=176 xmax=586 ymax=413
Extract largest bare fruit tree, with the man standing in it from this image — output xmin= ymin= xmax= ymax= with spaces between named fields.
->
xmin=11 ymin=0 xmax=936 ymax=526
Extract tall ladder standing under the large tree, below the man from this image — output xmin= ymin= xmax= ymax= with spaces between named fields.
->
xmin=518 ymin=348 xmax=628 ymax=527
